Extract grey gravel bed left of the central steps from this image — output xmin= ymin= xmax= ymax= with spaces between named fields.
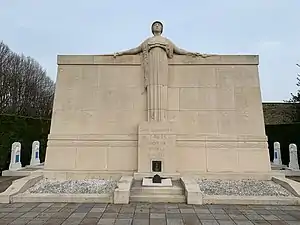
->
xmin=27 ymin=179 xmax=117 ymax=194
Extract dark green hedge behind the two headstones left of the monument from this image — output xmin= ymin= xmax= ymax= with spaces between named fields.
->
xmin=0 ymin=115 xmax=51 ymax=171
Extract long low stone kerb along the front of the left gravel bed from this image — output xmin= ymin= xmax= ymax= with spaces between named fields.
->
xmin=11 ymin=193 xmax=113 ymax=203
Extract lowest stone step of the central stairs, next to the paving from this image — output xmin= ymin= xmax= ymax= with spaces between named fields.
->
xmin=129 ymin=194 xmax=186 ymax=203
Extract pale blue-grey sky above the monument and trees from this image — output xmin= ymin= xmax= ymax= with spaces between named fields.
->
xmin=0 ymin=0 xmax=300 ymax=101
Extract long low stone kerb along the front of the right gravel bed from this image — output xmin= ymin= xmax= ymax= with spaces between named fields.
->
xmin=203 ymin=195 xmax=300 ymax=205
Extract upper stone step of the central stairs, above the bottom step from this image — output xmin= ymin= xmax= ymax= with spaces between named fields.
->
xmin=131 ymin=186 xmax=184 ymax=195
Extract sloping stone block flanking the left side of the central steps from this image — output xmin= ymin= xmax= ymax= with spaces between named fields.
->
xmin=114 ymin=176 xmax=133 ymax=204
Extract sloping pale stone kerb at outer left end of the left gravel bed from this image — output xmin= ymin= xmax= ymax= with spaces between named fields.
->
xmin=0 ymin=175 xmax=43 ymax=203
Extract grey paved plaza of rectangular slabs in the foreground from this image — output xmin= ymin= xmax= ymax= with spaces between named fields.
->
xmin=0 ymin=203 xmax=300 ymax=225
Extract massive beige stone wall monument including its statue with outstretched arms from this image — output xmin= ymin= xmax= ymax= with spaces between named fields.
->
xmin=45 ymin=21 xmax=271 ymax=177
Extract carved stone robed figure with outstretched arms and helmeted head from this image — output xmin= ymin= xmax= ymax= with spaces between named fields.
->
xmin=114 ymin=21 xmax=208 ymax=121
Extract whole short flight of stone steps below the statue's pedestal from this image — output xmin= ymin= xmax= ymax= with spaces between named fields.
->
xmin=129 ymin=180 xmax=186 ymax=203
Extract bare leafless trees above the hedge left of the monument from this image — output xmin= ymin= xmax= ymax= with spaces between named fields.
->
xmin=0 ymin=42 xmax=55 ymax=117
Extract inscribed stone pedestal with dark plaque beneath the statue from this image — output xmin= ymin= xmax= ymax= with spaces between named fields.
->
xmin=138 ymin=122 xmax=177 ymax=175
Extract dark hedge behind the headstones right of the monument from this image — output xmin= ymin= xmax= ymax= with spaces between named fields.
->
xmin=266 ymin=123 xmax=300 ymax=165
